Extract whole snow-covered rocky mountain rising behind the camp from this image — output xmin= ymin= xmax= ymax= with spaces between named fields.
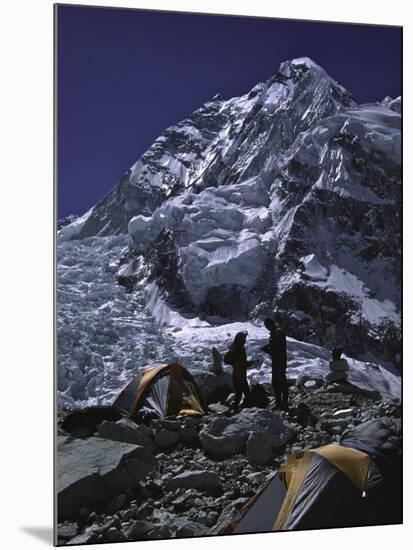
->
xmin=60 ymin=57 xmax=401 ymax=370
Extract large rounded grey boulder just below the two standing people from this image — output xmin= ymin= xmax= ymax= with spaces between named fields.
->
xmin=199 ymin=409 xmax=295 ymax=458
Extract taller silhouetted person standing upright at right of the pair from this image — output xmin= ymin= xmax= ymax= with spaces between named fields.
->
xmin=262 ymin=317 xmax=288 ymax=410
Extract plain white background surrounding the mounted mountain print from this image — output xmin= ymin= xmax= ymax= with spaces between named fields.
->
xmin=0 ymin=0 xmax=413 ymax=550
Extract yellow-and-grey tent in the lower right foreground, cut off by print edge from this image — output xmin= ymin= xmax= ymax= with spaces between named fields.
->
xmin=217 ymin=418 xmax=402 ymax=535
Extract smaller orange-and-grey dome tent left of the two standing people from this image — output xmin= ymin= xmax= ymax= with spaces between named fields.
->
xmin=113 ymin=363 xmax=205 ymax=418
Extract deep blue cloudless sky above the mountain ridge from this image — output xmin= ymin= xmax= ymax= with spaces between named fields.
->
xmin=57 ymin=5 xmax=401 ymax=218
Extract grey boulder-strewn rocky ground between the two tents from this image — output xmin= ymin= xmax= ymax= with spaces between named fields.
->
xmin=58 ymin=378 xmax=401 ymax=545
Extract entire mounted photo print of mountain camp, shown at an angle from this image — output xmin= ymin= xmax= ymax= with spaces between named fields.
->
xmin=55 ymin=5 xmax=402 ymax=546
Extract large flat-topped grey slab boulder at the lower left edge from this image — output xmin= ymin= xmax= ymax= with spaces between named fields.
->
xmin=57 ymin=437 xmax=156 ymax=521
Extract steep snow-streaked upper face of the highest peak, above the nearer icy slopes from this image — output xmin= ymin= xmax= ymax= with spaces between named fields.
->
xmin=59 ymin=58 xmax=356 ymax=242
